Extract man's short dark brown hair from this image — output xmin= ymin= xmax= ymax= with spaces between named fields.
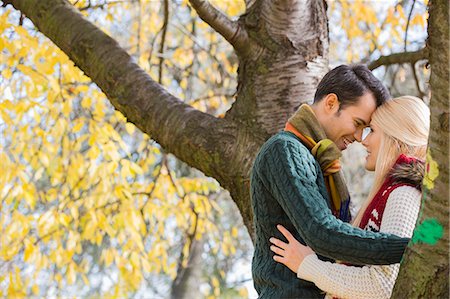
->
xmin=314 ymin=64 xmax=391 ymax=110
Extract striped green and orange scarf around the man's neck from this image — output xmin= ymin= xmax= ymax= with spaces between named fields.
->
xmin=284 ymin=104 xmax=351 ymax=222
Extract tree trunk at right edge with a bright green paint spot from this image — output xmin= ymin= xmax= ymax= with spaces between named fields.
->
xmin=392 ymin=0 xmax=450 ymax=298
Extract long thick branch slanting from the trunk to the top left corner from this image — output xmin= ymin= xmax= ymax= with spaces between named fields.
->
xmin=5 ymin=0 xmax=262 ymax=193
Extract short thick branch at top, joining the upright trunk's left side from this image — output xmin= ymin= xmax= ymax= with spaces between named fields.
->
xmin=189 ymin=0 xmax=259 ymax=56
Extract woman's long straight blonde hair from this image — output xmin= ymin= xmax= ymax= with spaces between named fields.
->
xmin=353 ymin=96 xmax=430 ymax=226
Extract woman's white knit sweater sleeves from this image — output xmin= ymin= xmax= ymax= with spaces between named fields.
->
xmin=297 ymin=186 xmax=421 ymax=299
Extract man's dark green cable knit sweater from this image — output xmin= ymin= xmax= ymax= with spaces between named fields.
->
xmin=250 ymin=132 xmax=409 ymax=298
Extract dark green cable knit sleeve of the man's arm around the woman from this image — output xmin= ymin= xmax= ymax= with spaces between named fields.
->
xmin=258 ymin=140 xmax=408 ymax=265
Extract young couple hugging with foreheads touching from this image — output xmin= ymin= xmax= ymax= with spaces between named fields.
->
xmin=250 ymin=65 xmax=430 ymax=298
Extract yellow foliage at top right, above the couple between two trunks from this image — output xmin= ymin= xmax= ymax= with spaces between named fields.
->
xmin=329 ymin=0 xmax=426 ymax=63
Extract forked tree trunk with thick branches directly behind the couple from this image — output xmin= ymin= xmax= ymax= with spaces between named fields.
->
xmin=2 ymin=0 xmax=328 ymax=238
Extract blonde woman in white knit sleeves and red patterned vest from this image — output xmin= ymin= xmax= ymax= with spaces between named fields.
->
xmin=270 ymin=96 xmax=430 ymax=298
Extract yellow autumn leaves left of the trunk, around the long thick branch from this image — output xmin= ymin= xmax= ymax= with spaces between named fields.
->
xmin=0 ymin=0 xmax=236 ymax=298
